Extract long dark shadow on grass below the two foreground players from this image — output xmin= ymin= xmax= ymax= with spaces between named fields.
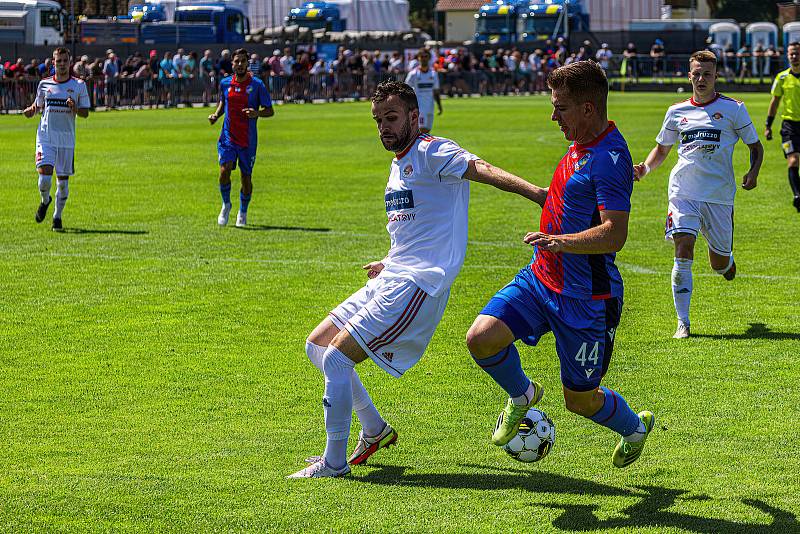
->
xmin=357 ymin=464 xmax=800 ymax=534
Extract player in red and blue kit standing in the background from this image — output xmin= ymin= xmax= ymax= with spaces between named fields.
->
xmin=208 ymin=48 xmax=275 ymax=228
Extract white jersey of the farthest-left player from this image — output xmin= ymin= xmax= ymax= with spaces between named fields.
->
xmin=36 ymin=77 xmax=91 ymax=148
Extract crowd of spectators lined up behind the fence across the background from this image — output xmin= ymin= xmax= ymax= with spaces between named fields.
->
xmin=0 ymin=38 xmax=781 ymax=111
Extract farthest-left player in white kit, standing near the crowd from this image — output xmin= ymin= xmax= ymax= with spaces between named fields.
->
xmin=23 ymin=48 xmax=91 ymax=231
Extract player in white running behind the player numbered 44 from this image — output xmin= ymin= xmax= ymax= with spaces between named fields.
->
xmin=634 ymin=50 xmax=764 ymax=339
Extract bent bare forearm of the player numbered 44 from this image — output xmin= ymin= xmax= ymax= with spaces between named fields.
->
xmin=522 ymin=210 xmax=629 ymax=254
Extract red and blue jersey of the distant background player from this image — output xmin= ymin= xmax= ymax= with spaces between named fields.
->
xmin=219 ymin=72 xmax=272 ymax=148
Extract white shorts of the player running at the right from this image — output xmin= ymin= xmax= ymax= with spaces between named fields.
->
xmin=664 ymin=197 xmax=733 ymax=256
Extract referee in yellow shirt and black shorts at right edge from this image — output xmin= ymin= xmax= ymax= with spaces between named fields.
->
xmin=764 ymin=41 xmax=800 ymax=212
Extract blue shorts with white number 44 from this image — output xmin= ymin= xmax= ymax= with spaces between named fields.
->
xmin=481 ymin=267 xmax=622 ymax=391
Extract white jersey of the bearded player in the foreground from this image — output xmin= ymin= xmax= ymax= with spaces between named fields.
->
xmin=383 ymin=134 xmax=478 ymax=297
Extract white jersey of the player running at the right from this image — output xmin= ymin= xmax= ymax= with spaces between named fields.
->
xmin=656 ymin=94 xmax=758 ymax=205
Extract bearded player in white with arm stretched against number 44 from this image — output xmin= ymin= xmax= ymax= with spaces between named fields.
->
xmin=289 ymin=81 xmax=547 ymax=478
